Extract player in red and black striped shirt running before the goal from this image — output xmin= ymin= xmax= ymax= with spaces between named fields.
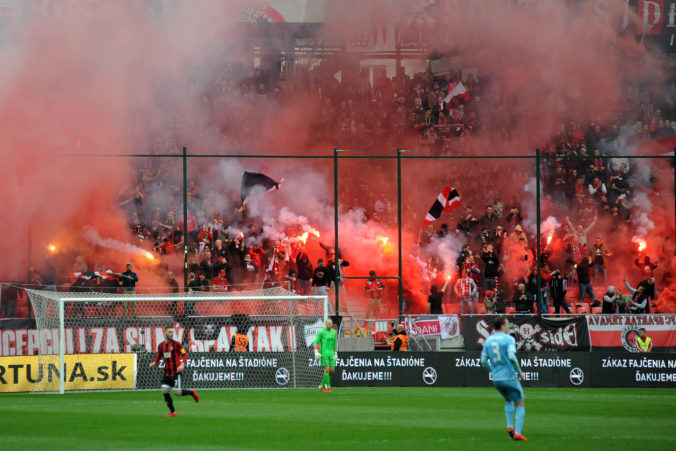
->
xmin=150 ymin=327 xmax=200 ymax=417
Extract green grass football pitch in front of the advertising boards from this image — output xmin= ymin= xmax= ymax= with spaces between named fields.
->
xmin=0 ymin=388 xmax=676 ymax=451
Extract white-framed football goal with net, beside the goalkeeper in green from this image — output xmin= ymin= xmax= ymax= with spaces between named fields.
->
xmin=23 ymin=288 xmax=328 ymax=393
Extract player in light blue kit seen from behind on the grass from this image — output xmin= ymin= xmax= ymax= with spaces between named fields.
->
xmin=481 ymin=316 xmax=527 ymax=440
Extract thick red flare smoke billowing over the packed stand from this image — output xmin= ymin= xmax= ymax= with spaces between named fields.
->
xmin=0 ymin=0 xmax=673 ymax=318
